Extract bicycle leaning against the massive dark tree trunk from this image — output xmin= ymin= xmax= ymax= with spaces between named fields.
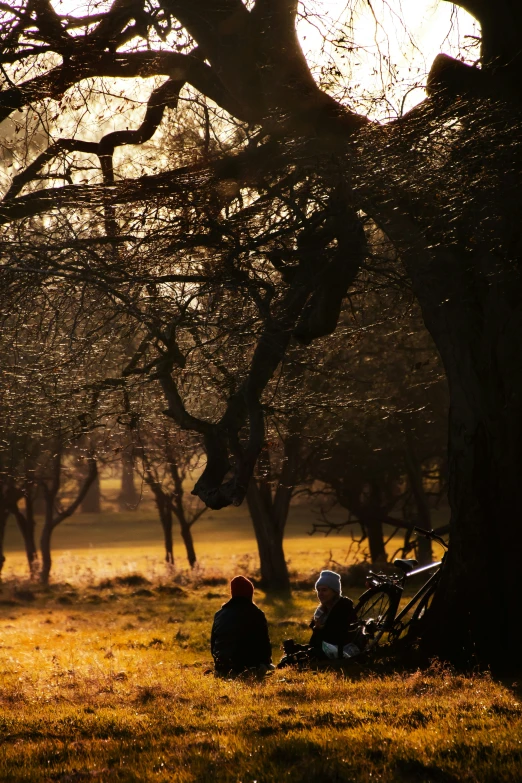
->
xmin=355 ymin=527 xmax=448 ymax=652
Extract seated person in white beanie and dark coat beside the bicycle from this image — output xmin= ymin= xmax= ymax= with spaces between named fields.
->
xmin=310 ymin=571 xmax=357 ymax=658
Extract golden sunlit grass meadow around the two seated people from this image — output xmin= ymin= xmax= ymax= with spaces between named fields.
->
xmin=0 ymin=509 xmax=522 ymax=783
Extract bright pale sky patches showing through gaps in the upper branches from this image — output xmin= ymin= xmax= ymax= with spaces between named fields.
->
xmin=0 ymin=0 xmax=479 ymax=191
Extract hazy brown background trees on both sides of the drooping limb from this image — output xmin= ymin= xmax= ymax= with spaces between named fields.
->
xmin=0 ymin=276 xmax=447 ymax=592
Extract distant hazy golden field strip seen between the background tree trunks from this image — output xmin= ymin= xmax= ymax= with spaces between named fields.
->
xmin=3 ymin=505 xmax=445 ymax=581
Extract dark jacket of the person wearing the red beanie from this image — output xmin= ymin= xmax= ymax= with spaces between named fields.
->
xmin=210 ymin=597 xmax=272 ymax=672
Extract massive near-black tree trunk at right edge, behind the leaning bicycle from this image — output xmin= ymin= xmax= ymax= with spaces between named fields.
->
xmin=364 ymin=152 xmax=522 ymax=671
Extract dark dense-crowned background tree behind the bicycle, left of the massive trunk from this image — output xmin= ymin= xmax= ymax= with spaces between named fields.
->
xmin=308 ymin=286 xmax=447 ymax=562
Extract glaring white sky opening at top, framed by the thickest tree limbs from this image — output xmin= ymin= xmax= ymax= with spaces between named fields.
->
xmin=47 ymin=0 xmax=478 ymax=121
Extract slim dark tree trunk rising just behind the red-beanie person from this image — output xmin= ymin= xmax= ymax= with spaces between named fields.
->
xmin=246 ymin=479 xmax=290 ymax=593
